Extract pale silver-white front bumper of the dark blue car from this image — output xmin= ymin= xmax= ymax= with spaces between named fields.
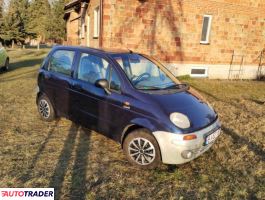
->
xmin=153 ymin=119 xmax=221 ymax=164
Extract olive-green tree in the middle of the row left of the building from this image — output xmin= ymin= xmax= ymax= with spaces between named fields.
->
xmin=27 ymin=0 xmax=51 ymax=41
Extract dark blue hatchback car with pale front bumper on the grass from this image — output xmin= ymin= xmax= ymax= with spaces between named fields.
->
xmin=37 ymin=46 xmax=220 ymax=169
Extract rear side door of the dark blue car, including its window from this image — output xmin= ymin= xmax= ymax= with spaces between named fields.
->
xmin=42 ymin=49 xmax=75 ymax=118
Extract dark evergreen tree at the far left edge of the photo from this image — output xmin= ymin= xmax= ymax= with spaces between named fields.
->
xmin=0 ymin=0 xmax=28 ymax=44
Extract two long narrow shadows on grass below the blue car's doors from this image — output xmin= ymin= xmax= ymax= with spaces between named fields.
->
xmin=49 ymin=123 xmax=90 ymax=200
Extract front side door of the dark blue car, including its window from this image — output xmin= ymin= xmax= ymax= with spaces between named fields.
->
xmin=72 ymin=53 xmax=131 ymax=139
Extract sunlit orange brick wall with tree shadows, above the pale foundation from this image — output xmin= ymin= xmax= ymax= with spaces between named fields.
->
xmin=101 ymin=0 xmax=265 ymax=65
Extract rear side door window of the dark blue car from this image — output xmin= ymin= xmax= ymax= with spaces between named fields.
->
xmin=48 ymin=50 xmax=75 ymax=76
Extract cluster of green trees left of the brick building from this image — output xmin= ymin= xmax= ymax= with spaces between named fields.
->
xmin=0 ymin=0 xmax=69 ymax=44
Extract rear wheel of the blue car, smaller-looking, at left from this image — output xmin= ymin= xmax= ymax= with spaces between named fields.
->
xmin=37 ymin=95 xmax=55 ymax=122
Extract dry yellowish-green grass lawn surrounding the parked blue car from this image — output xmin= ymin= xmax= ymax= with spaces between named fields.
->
xmin=0 ymin=50 xmax=265 ymax=200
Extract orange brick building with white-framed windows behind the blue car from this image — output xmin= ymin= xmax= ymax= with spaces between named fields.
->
xmin=64 ymin=0 xmax=265 ymax=78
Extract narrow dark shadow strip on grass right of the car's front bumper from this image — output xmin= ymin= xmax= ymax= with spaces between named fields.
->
xmin=222 ymin=126 xmax=265 ymax=161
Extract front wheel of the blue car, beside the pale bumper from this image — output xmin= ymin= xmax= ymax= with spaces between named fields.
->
xmin=123 ymin=128 xmax=161 ymax=169
